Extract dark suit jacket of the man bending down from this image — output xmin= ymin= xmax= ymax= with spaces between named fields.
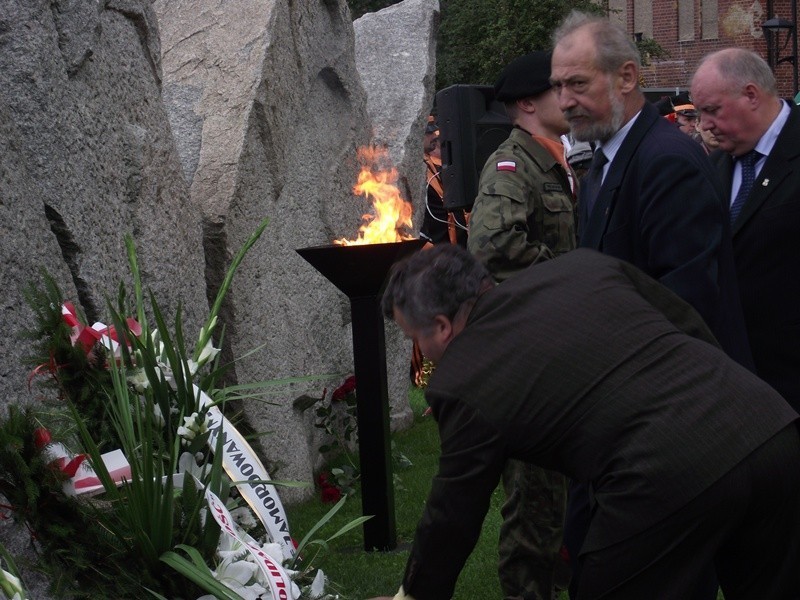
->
xmin=403 ymin=249 xmax=797 ymax=600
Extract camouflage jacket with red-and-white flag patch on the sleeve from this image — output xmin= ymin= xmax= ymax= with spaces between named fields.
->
xmin=467 ymin=127 xmax=576 ymax=281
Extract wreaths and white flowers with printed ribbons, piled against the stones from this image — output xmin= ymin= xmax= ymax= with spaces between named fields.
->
xmin=0 ymin=220 xmax=365 ymax=600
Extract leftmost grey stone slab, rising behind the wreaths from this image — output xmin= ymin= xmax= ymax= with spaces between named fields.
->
xmin=0 ymin=0 xmax=207 ymax=598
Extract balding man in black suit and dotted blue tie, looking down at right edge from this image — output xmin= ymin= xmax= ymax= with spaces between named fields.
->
xmin=692 ymin=48 xmax=800 ymax=409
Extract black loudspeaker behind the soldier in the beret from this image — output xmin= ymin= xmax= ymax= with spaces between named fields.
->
xmin=436 ymin=85 xmax=512 ymax=210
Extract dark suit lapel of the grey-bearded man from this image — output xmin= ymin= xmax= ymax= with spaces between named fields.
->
xmin=581 ymin=102 xmax=659 ymax=249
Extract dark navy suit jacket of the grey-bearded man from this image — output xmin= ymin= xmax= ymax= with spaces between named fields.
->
xmin=579 ymin=103 xmax=753 ymax=369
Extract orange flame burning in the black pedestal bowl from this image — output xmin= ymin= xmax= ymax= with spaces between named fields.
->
xmin=333 ymin=146 xmax=414 ymax=246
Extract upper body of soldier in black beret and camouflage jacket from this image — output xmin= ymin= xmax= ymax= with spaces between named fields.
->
xmin=467 ymin=52 xmax=575 ymax=281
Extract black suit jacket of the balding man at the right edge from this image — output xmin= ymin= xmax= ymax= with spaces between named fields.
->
xmin=711 ymin=106 xmax=800 ymax=409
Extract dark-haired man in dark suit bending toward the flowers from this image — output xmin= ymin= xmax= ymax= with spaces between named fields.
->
xmin=376 ymin=246 xmax=800 ymax=600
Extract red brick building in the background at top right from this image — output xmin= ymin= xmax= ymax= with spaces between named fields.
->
xmin=605 ymin=0 xmax=797 ymax=98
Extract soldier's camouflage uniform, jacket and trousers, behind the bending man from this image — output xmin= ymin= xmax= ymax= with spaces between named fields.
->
xmin=467 ymin=127 xmax=576 ymax=600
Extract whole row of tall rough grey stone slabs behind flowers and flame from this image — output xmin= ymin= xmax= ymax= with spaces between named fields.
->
xmin=0 ymin=0 xmax=438 ymax=584
